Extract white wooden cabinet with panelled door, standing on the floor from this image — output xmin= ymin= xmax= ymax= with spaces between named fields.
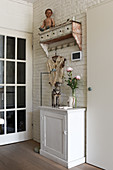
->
xmin=40 ymin=106 xmax=85 ymax=168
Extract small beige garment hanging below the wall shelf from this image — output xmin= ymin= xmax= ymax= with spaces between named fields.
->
xmin=47 ymin=55 xmax=66 ymax=87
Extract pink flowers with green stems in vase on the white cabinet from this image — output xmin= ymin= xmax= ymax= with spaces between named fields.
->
xmin=65 ymin=67 xmax=80 ymax=108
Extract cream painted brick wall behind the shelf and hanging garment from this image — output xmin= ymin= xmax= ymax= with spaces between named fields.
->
xmin=33 ymin=0 xmax=108 ymax=141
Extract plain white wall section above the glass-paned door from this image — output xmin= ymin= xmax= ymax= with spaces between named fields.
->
xmin=0 ymin=0 xmax=33 ymax=33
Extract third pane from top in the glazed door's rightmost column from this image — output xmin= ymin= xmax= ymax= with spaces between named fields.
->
xmin=17 ymin=86 xmax=26 ymax=108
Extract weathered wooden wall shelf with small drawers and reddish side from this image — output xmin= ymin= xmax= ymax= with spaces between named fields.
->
xmin=39 ymin=21 xmax=82 ymax=56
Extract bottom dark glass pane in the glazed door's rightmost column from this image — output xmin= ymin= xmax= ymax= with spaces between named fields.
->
xmin=17 ymin=110 xmax=26 ymax=132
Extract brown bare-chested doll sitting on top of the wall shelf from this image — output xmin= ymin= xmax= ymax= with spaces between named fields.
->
xmin=39 ymin=9 xmax=55 ymax=31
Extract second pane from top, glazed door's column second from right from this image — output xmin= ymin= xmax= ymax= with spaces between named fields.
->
xmin=6 ymin=61 xmax=15 ymax=84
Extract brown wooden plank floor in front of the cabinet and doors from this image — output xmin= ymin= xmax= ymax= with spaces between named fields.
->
xmin=0 ymin=140 xmax=100 ymax=170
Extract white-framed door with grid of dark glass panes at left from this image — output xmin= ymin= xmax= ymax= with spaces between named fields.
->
xmin=0 ymin=29 xmax=32 ymax=145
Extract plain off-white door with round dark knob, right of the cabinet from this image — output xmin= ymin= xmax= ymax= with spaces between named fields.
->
xmin=87 ymin=1 xmax=113 ymax=170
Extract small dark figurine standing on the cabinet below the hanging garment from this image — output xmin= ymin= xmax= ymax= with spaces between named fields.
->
xmin=52 ymin=82 xmax=61 ymax=107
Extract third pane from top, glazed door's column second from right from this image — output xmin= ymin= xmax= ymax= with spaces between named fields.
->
xmin=6 ymin=86 xmax=15 ymax=109
